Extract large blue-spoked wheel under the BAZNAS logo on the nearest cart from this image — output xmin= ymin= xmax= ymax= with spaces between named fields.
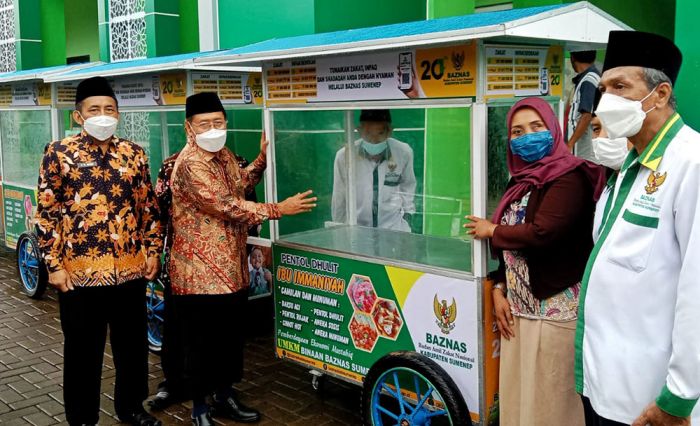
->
xmin=362 ymin=352 xmax=472 ymax=426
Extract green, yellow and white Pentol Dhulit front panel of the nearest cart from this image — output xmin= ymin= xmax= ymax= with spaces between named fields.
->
xmin=273 ymin=246 xmax=482 ymax=421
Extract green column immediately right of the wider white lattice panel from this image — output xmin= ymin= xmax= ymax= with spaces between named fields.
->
xmin=146 ymin=0 xmax=181 ymax=58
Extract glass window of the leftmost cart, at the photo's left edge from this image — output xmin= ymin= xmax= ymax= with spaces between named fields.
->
xmin=0 ymin=110 xmax=51 ymax=187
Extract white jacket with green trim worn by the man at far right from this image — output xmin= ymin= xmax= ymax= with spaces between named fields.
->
xmin=576 ymin=114 xmax=700 ymax=424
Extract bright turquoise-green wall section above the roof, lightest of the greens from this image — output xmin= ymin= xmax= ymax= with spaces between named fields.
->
xmin=219 ymin=0 xmax=314 ymax=49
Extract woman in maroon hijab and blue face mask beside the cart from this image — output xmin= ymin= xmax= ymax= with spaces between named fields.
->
xmin=465 ymin=98 xmax=605 ymax=426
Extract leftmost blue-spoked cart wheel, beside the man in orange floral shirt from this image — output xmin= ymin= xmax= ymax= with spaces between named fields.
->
xmin=16 ymin=232 xmax=49 ymax=299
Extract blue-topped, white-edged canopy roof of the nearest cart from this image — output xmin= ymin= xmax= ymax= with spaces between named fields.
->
xmin=194 ymin=1 xmax=632 ymax=67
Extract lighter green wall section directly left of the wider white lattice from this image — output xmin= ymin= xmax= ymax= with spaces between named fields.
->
xmin=64 ymin=0 xmax=100 ymax=63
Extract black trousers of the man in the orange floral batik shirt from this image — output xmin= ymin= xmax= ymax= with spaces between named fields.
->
xmin=59 ymin=280 xmax=148 ymax=425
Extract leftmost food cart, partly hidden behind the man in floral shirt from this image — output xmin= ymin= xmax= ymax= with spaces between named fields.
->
xmin=0 ymin=64 xmax=97 ymax=297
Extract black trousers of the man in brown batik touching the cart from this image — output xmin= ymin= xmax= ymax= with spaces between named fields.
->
xmin=172 ymin=290 xmax=248 ymax=399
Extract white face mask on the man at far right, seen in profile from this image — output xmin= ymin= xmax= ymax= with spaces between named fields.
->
xmin=595 ymin=88 xmax=656 ymax=139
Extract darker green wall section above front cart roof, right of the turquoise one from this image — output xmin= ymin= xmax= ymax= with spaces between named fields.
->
xmin=314 ymin=0 xmax=426 ymax=33
